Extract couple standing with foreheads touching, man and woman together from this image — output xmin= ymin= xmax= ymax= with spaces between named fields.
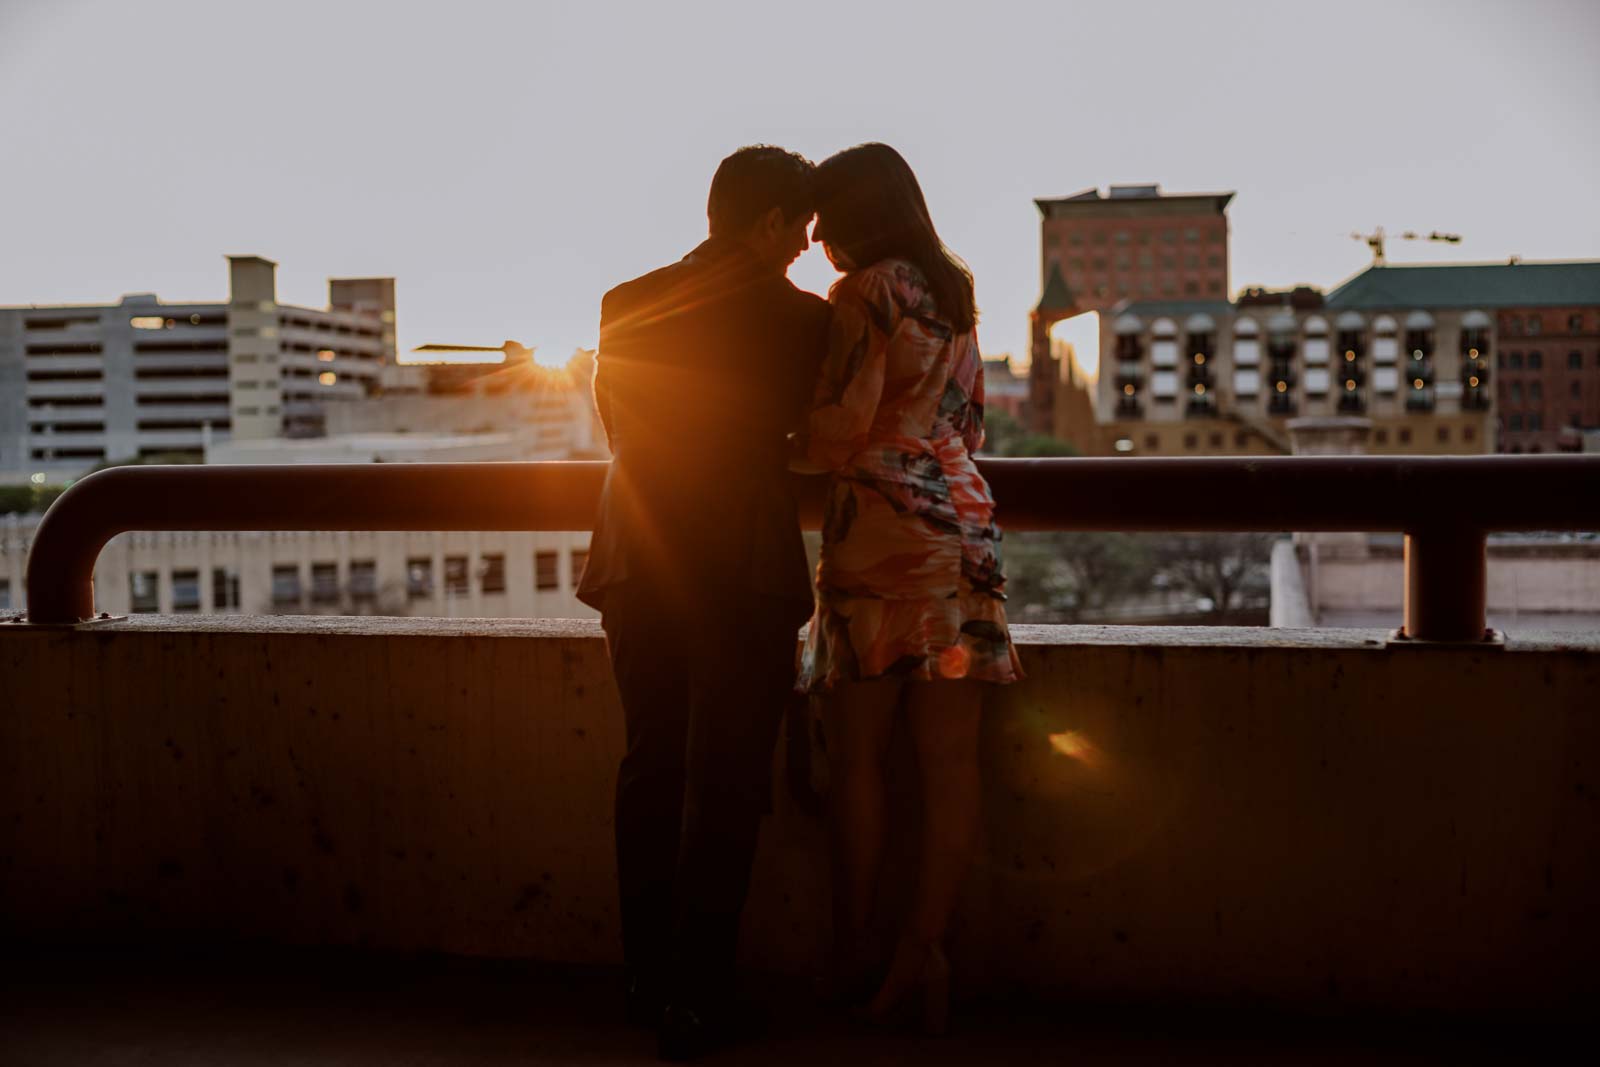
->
xmin=578 ymin=144 xmax=1021 ymax=1059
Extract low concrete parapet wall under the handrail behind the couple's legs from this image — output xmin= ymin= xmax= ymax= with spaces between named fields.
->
xmin=0 ymin=616 xmax=1600 ymax=1013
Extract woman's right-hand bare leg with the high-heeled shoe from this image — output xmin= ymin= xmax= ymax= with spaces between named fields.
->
xmin=869 ymin=681 xmax=984 ymax=1029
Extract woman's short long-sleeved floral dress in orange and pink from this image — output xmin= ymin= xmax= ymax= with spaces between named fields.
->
xmin=798 ymin=259 xmax=1022 ymax=693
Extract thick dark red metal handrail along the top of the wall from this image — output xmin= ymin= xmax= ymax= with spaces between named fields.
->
xmin=27 ymin=456 xmax=1600 ymax=641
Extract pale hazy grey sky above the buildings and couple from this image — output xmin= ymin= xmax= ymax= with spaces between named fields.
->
xmin=0 ymin=0 xmax=1600 ymax=367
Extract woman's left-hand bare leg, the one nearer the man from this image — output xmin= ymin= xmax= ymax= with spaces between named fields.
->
xmin=822 ymin=680 xmax=904 ymax=992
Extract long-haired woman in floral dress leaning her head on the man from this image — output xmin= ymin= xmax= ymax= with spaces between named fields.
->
xmin=798 ymin=144 xmax=1021 ymax=1032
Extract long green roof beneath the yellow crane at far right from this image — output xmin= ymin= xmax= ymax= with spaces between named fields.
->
xmin=1328 ymin=261 xmax=1600 ymax=309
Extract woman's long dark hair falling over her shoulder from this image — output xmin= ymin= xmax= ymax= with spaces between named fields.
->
xmin=814 ymin=142 xmax=978 ymax=333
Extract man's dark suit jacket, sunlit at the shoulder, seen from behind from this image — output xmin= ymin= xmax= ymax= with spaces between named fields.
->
xmin=578 ymin=238 xmax=829 ymax=629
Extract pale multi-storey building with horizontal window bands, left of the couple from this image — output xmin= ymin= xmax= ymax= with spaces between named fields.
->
xmin=0 ymin=256 xmax=395 ymax=483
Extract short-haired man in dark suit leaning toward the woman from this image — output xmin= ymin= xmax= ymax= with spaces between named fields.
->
xmin=578 ymin=146 xmax=829 ymax=1059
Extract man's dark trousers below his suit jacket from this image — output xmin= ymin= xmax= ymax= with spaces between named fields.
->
xmin=603 ymin=581 xmax=798 ymax=1005
